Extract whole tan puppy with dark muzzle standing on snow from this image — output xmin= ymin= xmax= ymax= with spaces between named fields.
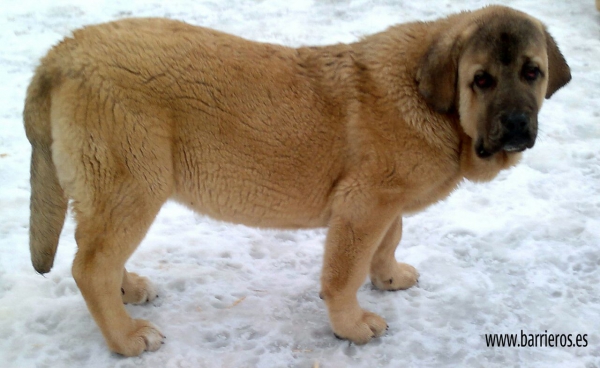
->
xmin=24 ymin=6 xmax=570 ymax=356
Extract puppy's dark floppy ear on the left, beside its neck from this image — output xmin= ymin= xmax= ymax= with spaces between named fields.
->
xmin=417 ymin=36 xmax=460 ymax=113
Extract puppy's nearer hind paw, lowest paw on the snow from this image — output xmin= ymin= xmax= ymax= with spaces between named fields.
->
xmin=109 ymin=319 xmax=165 ymax=356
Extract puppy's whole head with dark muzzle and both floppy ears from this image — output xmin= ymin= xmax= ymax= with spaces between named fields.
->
xmin=417 ymin=6 xmax=571 ymax=158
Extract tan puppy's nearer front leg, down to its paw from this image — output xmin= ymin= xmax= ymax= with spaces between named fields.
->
xmin=321 ymin=196 xmax=397 ymax=344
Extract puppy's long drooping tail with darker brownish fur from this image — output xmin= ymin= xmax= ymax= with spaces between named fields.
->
xmin=23 ymin=58 xmax=68 ymax=274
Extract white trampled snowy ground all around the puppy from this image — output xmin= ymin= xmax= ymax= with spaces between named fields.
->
xmin=0 ymin=0 xmax=600 ymax=368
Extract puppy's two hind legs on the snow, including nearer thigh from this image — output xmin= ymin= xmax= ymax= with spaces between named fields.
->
xmin=53 ymin=94 xmax=173 ymax=356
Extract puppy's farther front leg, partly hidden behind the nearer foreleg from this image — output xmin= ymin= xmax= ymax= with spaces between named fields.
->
xmin=371 ymin=216 xmax=419 ymax=290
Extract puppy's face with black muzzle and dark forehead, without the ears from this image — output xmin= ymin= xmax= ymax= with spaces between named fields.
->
xmin=457 ymin=18 xmax=548 ymax=158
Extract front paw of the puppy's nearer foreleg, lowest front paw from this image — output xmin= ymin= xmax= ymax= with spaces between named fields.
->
xmin=332 ymin=309 xmax=388 ymax=345
